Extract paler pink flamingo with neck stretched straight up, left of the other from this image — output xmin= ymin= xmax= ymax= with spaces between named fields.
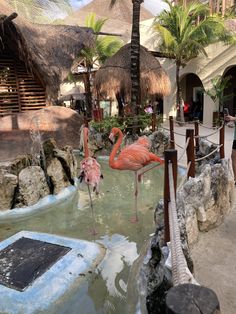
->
xmin=79 ymin=127 xmax=103 ymax=234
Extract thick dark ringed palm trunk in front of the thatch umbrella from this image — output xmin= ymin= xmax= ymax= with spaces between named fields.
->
xmin=110 ymin=0 xmax=144 ymax=115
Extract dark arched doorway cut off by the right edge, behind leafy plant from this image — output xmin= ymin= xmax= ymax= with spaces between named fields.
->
xmin=223 ymin=65 xmax=236 ymax=116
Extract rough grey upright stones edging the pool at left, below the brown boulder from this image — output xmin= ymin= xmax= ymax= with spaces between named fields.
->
xmin=0 ymin=139 xmax=77 ymax=211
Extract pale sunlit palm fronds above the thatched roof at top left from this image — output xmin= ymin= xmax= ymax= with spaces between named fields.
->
xmin=8 ymin=0 xmax=72 ymax=23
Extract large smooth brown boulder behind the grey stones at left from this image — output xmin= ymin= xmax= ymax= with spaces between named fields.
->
xmin=0 ymin=106 xmax=84 ymax=160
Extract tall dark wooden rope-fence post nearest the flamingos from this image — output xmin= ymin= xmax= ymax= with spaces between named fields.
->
xmin=164 ymin=149 xmax=177 ymax=242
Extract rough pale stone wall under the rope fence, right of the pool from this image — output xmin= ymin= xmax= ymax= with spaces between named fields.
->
xmin=141 ymin=159 xmax=234 ymax=314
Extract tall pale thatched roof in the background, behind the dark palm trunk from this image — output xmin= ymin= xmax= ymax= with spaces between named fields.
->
xmin=63 ymin=0 xmax=153 ymax=42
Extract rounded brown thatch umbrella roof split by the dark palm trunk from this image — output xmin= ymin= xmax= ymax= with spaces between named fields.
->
xmin=93 ymin=44 xmax=170 ymax=101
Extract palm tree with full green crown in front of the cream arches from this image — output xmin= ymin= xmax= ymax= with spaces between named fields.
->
xmin=154 ymin=0 xmax=233 ymax=122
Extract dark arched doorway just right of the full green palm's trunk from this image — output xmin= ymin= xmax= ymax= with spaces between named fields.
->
xmin=180 ymin=73 xmax=204 ymax=121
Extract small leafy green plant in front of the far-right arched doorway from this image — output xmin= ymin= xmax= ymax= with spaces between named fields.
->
xmin=204 ymin=75 xmax=233 ymax=112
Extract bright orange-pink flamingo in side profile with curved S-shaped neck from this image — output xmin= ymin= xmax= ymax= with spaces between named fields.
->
xmin=109 ymin=128 xmax=164 ymax=222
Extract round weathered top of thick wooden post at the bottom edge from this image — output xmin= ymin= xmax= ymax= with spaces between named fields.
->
xmin=165 ymin=284 xmax=220 ymax=314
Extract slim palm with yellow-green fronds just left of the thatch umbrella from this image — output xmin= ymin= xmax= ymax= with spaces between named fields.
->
xmin=78 ymin=13 xmax=123 ymax=117
